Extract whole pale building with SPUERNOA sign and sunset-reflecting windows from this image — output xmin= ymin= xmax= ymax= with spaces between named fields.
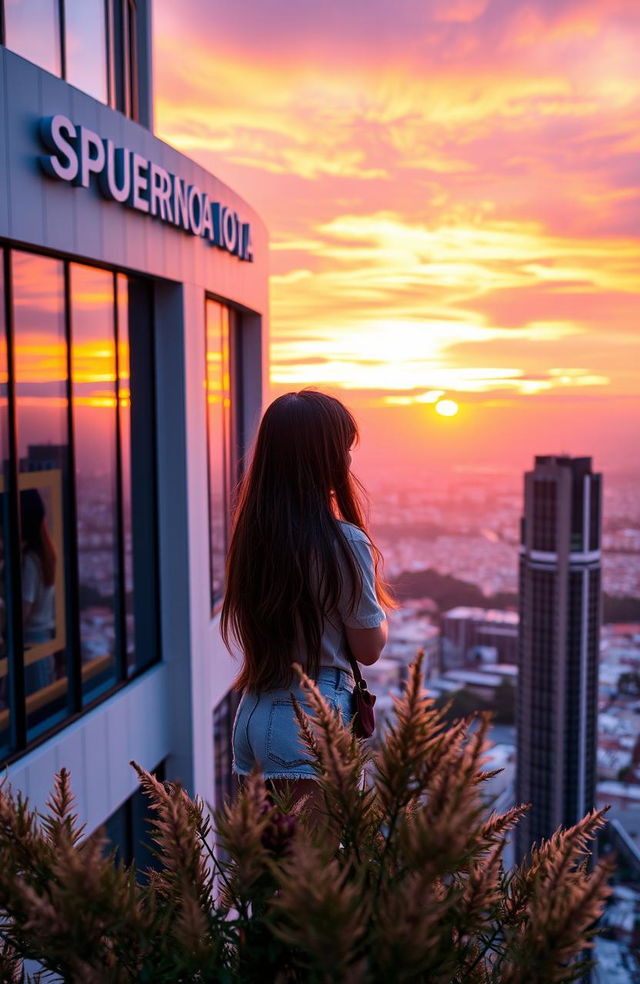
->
xmin=0 ymin=0 xmax=268 ymax=853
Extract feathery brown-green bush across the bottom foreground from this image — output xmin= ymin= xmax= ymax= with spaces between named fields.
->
xmin=0 ymin=658 xmax=611 ymax=984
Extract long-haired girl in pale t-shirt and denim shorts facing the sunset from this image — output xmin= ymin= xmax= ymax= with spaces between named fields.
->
xmin=221 ymin=390 xmax=391 ymax=799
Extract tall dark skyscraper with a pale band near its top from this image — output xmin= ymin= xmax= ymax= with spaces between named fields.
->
xmin=516 ymin=455 xmax=602 ymax=856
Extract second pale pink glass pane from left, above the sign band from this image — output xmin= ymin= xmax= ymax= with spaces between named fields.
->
xmin=64 ymin=0 xmax=107 ymax=103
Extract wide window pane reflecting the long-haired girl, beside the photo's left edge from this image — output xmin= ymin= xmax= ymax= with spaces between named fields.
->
xmin=11 ymin=250 xmax=69 ymax=739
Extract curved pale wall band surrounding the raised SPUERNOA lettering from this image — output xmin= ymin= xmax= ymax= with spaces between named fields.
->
xmin=0 ymin=49 xmax=267 ymax=311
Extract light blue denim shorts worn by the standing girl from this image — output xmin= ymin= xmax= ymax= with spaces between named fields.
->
xmin=233 ymin=666 xmax=354 ymax=779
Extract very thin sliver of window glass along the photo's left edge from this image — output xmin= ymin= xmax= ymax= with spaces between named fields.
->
xmin=0 ymin=258 xmax=11 ymax=760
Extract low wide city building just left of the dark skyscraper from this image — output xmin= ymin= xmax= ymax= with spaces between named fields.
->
xmin=442 ymin=605 xmax=518 ymax=670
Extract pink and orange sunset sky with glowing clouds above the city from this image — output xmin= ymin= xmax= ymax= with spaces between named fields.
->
xmin=154 ymin=0 xmax=640 ymax=481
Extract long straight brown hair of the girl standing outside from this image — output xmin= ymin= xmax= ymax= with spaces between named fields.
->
xmin=221 ymin=390 xmax=392 ymax=692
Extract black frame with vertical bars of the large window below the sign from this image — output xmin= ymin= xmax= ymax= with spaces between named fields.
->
xmin=0 ymin=239 xmax=162 ymax=768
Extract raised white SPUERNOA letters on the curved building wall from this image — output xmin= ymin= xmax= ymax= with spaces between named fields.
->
xmin=40 ymin=113 xmax=253 ymax=262
